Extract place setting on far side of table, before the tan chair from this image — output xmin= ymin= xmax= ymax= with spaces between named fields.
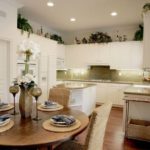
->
xmin=38 ymin=100 xmax=64 ymax=111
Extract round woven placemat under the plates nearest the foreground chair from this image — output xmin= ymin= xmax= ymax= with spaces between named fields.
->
xmin=42 ymin=119 xmax=81 ymax=132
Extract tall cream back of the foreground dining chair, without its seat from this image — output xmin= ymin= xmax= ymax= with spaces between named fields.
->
xmin=85 ymin=103 xmax=112 ymax=150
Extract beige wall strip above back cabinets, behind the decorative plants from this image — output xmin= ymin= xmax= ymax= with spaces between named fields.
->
xmin=62 ymin=25 xmax=138 ymax=44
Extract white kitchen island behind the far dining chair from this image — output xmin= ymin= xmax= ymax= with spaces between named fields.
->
xmin=57 ymin=82 xmax=96 ymax=116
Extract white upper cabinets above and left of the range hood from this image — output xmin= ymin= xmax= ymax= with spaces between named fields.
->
xmin=66 ymin=44 xmax=109 ymax=68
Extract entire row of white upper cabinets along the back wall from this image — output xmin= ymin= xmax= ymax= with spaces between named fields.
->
xmin=66 ymin=41 xmax=143 ymax=69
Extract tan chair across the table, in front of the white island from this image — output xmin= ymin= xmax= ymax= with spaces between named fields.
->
xmin=49 ymin=87 xmax=70 ymax=107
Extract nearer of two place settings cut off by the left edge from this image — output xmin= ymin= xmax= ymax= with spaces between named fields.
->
xmin=0 ymin=114 xmax=14 ymax=133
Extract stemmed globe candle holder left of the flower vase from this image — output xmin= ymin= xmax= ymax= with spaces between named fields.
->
xmin=9 ymin=85 xmax=19 ymax=115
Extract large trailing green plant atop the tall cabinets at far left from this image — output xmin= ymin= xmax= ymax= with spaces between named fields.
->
xmin=17 ymin=14 xmax=33 ymax=37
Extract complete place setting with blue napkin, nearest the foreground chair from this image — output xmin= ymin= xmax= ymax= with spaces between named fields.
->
xmin=42 ymin=115 xmax=81 ymax=132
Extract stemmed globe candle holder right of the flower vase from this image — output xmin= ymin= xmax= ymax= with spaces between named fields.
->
xmin=31 ymin=87 xmax=42 ymax=121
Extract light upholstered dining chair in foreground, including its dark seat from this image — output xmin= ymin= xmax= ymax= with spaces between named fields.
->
xmin=54 ymin=102 xmax=112 ymax=150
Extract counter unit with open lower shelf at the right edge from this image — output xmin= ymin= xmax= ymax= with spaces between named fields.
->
xmin=124 ymin=85 xmax=150 ymax=141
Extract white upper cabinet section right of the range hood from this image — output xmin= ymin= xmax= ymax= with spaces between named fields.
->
xmin=110 ymin=41 xmax=143 ymax=69
